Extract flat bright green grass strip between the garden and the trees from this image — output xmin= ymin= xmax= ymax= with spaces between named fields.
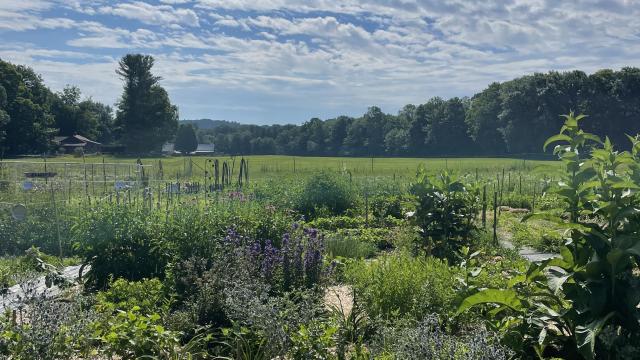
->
xmin=5 ymin=155 xmax=560 ymax=180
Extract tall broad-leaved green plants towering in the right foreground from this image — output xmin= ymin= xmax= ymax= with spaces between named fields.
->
xmin=459 ymin=113 xmax=640 ymax=359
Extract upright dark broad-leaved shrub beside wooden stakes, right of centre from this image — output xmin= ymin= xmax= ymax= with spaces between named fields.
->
xmin=411 ymin=167 xmax=479 ymax=257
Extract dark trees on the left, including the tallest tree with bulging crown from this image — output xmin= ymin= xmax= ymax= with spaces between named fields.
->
xmin=0 ymin=54 xmax=178 ymax=157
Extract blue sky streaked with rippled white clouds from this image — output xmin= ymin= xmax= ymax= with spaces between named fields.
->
xmin=0 ymin=0 xmax=640 ymax=124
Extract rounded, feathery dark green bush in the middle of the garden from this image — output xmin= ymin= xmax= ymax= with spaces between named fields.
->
xmin=296 ymin=172 xmax=356 ymax=218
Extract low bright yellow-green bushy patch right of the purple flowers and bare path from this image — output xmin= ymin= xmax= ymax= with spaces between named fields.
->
xmin=346 ymin=253 xmax=459 ymax=319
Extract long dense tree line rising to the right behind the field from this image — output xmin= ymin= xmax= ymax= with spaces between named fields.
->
xmin=198 ymin=67 xmax=640 ymax=156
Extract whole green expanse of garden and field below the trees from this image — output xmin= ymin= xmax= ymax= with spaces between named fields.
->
xmin=0 ymin=117 xmax=640 ymax=360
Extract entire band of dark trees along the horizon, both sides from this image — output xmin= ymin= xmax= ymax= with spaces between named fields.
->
xmin=0 ymin=54 xmax=640 ymax=156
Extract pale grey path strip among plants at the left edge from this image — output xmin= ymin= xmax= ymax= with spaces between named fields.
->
xmin=0 ymin=265 xmax=89 ymax=312
